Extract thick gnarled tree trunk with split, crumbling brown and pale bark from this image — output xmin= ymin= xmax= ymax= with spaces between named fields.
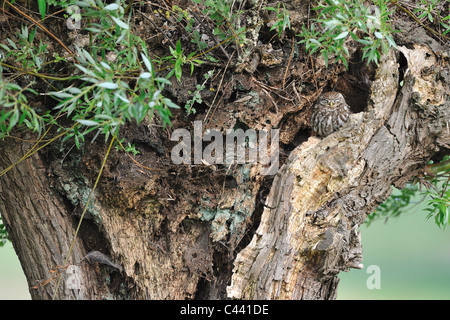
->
xmin=0 ymin=7 xmax=450 ymax=299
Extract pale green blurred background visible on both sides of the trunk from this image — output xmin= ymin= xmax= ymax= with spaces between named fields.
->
xmin=0 ymin=206 xmax=450 ymax=300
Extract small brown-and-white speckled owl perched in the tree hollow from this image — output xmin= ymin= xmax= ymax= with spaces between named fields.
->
xmin=311 ymin=91 xmax=351 ymax=137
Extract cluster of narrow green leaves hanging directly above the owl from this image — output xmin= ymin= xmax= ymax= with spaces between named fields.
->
xmin=299 ymin=0 xmax=396 ymax=67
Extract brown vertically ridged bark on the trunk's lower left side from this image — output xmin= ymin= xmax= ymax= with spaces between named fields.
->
xmin=0 ymin=141 xmax=105 ymax=299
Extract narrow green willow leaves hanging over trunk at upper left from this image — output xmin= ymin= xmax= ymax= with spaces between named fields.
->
xmin=0 ymin=0 xmax=181 ymax=148
